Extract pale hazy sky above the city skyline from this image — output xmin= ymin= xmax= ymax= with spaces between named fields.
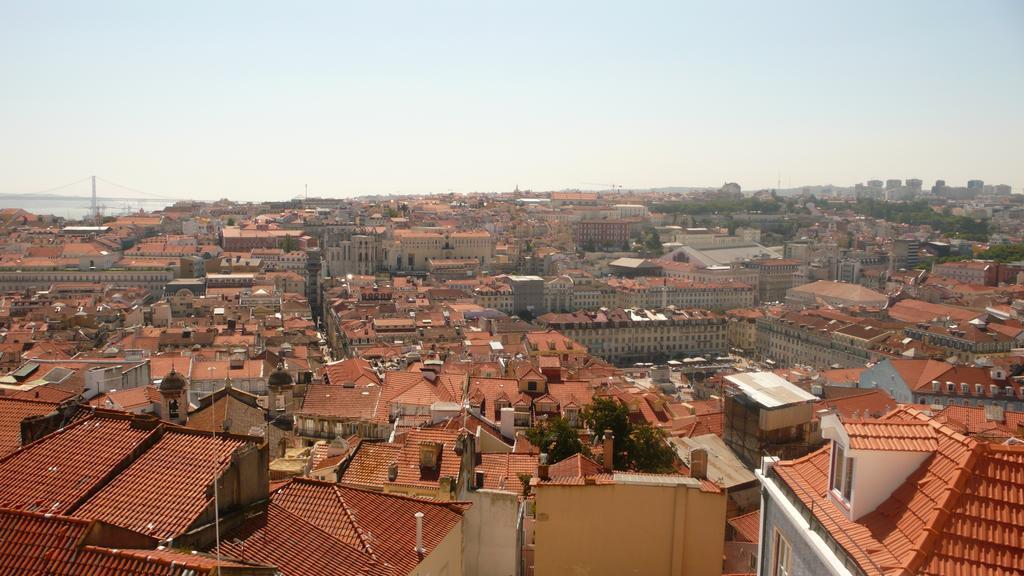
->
xmin=0 ymin=0 xmax=1024 ymax=199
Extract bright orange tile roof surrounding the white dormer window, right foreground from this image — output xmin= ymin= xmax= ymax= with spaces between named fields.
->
xmin=773 ymin=408 xmax=1024 ymax=576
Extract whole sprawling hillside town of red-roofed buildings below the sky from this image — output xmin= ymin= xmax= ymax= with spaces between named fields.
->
xmin=0 ymin=179 xmax=1024 ymax=576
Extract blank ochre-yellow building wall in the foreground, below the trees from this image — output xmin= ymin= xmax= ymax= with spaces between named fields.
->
xmin=534 ymin=484 xmax=726 ymax=576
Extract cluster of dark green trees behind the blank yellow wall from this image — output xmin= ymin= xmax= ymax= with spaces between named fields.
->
xmin=525 ymin=398 xmax=676 ymax=472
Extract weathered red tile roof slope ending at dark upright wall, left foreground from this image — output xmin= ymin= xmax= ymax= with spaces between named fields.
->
xmin=74 ymin=428 xmax=250 ymax=539
